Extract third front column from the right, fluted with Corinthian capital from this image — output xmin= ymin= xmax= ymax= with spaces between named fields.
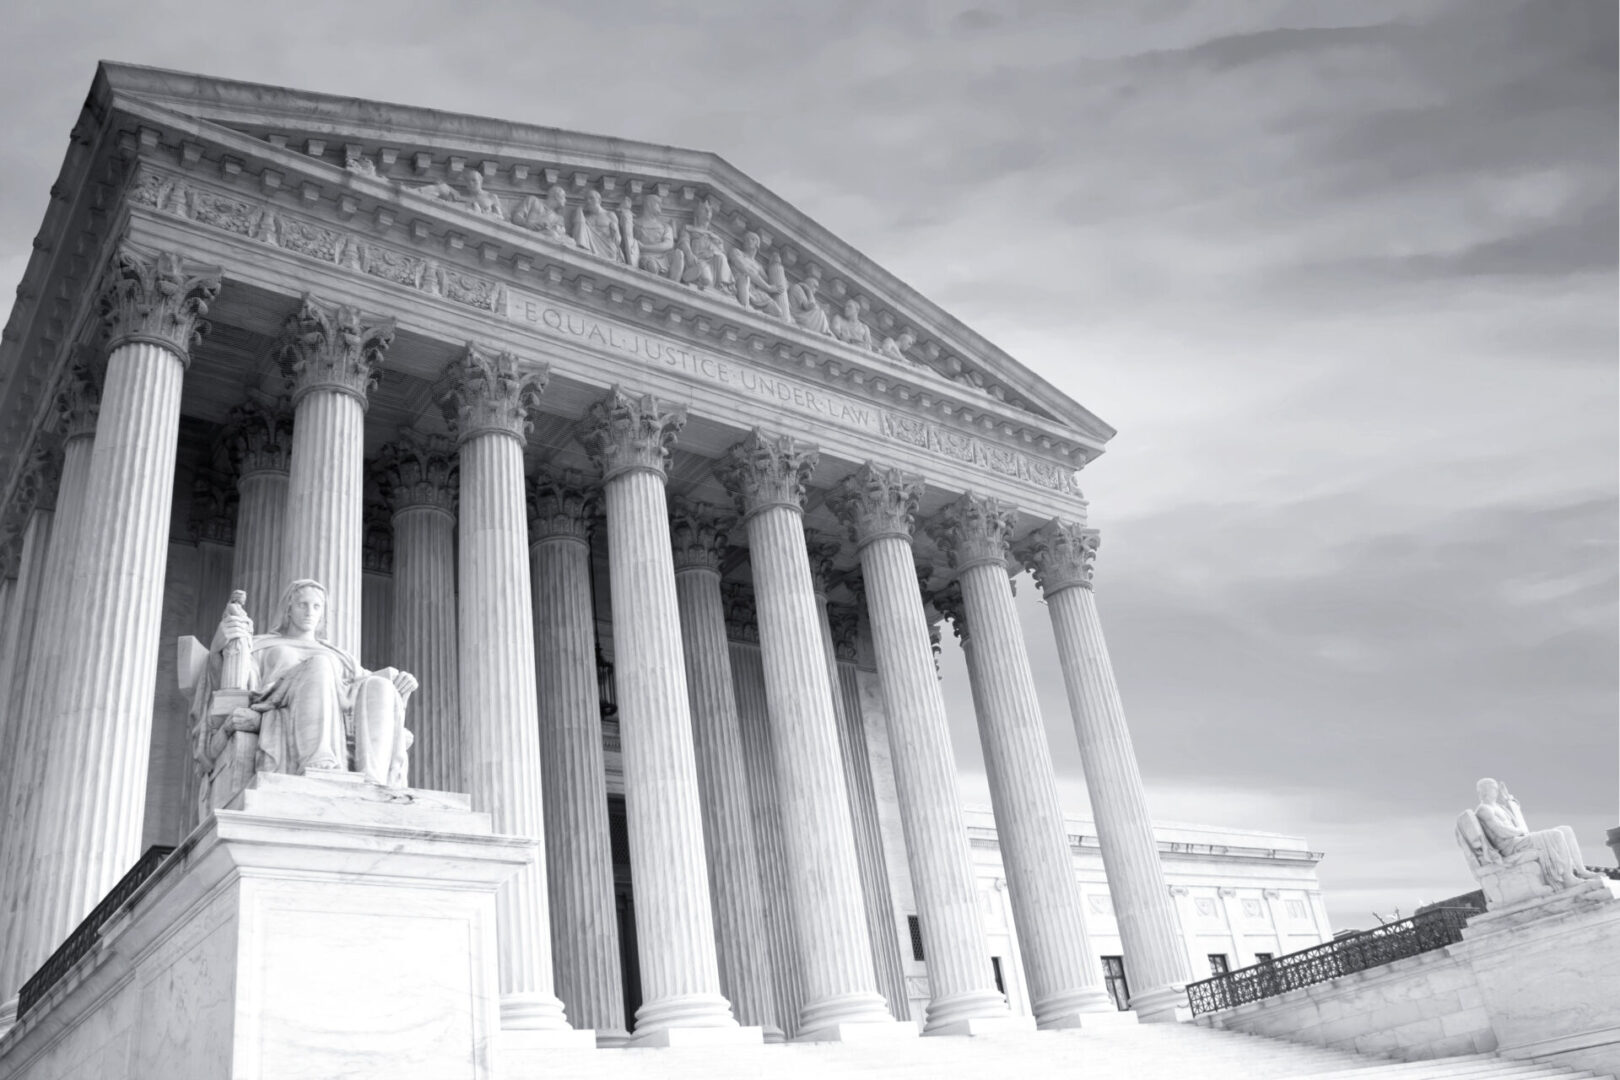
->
xmin=829 ymin=463 xmax=1019 ymax=1033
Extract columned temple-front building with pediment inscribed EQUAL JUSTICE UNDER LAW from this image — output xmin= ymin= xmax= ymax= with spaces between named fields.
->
xmin=0 ymin=65 xmax=1211 ymax=1054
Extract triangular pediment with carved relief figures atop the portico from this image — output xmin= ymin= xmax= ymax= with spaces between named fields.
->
xmin=92 ymin=63 xmax=1115 ymax=458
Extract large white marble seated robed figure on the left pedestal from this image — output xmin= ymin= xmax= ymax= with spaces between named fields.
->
xmin=193 ymin=580 xmax=416 ymax=793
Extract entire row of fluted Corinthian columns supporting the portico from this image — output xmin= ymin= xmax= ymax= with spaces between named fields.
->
xmin=0 ymin=241 xmax=1186 ymax=1043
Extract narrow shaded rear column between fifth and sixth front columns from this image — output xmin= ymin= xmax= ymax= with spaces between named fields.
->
xmin=805 ymin=550 xmax=910 ymax=1020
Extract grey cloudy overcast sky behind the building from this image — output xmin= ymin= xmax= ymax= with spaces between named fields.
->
xmin=0 ymin=0 xmax=1620 ymax=926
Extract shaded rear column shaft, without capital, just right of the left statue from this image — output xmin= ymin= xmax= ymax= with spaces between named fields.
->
xmin=393 ymin=505 xmax=467 ymax=792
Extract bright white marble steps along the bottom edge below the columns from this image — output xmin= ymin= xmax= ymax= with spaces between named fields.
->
xmin=502 ymin=1023 xmax=1614 ymax=1080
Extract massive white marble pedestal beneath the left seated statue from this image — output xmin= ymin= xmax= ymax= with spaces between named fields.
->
xmin=0 ymin=772 xmax=536 ymax=1080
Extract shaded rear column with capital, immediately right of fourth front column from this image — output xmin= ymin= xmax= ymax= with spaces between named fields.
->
xmin=671 ymin=502 xmax=782 ymax=1043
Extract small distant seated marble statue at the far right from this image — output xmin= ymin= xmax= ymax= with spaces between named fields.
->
xmin=1458 ymin=777 xmax=1601 ymax=907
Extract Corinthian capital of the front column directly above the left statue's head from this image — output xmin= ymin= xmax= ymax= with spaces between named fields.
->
xmin=277 ymin=293 xmax=394 ymax=406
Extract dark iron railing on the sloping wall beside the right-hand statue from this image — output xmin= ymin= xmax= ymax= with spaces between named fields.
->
xmin=1187 ymin=907 xmax=1477 ymax=1015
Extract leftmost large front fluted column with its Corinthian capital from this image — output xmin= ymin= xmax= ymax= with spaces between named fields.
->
xmin=24 ymin=246 xmax=220 ymax=967
